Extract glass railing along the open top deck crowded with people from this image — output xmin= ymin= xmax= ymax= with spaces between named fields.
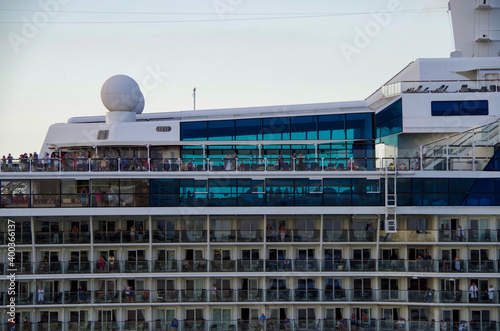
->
xmin=0 ymin=153 xmax=472 ymax=176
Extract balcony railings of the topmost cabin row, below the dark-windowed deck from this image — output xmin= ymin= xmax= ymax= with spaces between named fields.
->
xmin=7 ymin=229 xmax=500 ymax=245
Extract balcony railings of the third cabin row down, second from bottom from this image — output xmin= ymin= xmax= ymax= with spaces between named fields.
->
xmin=2 ymin=288 xmax=499 ymax=305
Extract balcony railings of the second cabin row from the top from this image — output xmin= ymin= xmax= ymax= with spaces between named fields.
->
xmin=5 ymin=259 xmax=500 ymax=275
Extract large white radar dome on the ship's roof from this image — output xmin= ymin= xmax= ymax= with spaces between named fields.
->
xmin=101 ymin=75 xmax=144 ymax=112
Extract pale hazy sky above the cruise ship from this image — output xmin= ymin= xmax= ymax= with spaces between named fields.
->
xmin=0 ymin=0 xmax=454 ymax=157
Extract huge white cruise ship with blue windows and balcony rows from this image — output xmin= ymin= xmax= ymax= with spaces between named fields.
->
xmin=0 ymin=0 xmax=500 ymax=331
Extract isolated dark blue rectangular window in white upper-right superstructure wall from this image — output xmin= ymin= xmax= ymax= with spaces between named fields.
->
xmin=431 ymin=100 xmax=488 ymax=116
